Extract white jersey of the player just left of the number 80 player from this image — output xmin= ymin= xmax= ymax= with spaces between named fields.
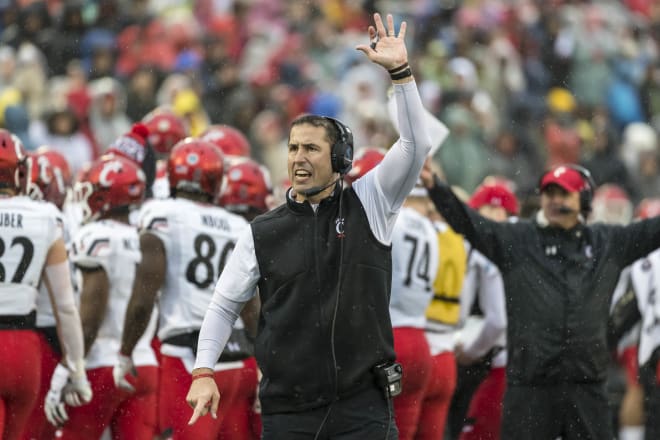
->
xmin=71 ymin=220 xmax=156 ymax=369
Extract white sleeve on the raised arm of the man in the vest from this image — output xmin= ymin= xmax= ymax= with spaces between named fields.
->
xmin=353 ymin=81 xmax=431 ymax=244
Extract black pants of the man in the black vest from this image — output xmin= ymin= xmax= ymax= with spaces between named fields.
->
xmin=261 ymin=388 xmax=399 ymax=440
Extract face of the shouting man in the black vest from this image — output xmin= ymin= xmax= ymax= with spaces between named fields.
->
xmin=288 ymin=124 xmax=336 ymax=203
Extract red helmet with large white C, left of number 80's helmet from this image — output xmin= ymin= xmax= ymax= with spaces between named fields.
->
xmin=76 ymin=155 xmax=146 ymax=222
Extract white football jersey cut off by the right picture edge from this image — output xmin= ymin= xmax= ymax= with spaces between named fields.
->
xmin=630 ymin=250 xmax=660 ymax=365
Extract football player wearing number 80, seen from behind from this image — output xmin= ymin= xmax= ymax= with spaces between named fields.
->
xmin=115 ymin=138 xmax=249 ymax=439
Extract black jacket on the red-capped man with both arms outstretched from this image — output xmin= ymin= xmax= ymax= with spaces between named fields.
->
xmin=429 ymin=179 xmax=660 ymax=385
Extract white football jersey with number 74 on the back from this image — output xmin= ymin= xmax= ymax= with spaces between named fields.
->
xmin=390 ymin=206 xmax=439 ymax=328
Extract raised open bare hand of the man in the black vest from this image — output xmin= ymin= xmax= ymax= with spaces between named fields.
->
xmin=356 ymin=13 xmax=408 ymax=70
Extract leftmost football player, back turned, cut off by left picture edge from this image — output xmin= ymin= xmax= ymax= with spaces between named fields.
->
xmin=0 ymin=129 xmax=92 ymax=438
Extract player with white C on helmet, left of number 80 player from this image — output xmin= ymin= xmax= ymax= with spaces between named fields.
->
xmin=51 ymin=155 xmax=158 ymax=440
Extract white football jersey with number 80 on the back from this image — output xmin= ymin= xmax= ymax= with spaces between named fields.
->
xmin=139 ymin=198 xmax=247 ymax=341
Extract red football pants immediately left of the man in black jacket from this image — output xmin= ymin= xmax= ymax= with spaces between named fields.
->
xmin=460 ymin=367 xmax=506 ymax=440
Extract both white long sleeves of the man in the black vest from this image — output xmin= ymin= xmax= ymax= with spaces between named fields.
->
xmin=195 ymin=82 xmax=444 ymax=368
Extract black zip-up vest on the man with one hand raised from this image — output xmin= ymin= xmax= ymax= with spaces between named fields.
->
xmin=251 ymin=188 xmax=395 ymax=414
